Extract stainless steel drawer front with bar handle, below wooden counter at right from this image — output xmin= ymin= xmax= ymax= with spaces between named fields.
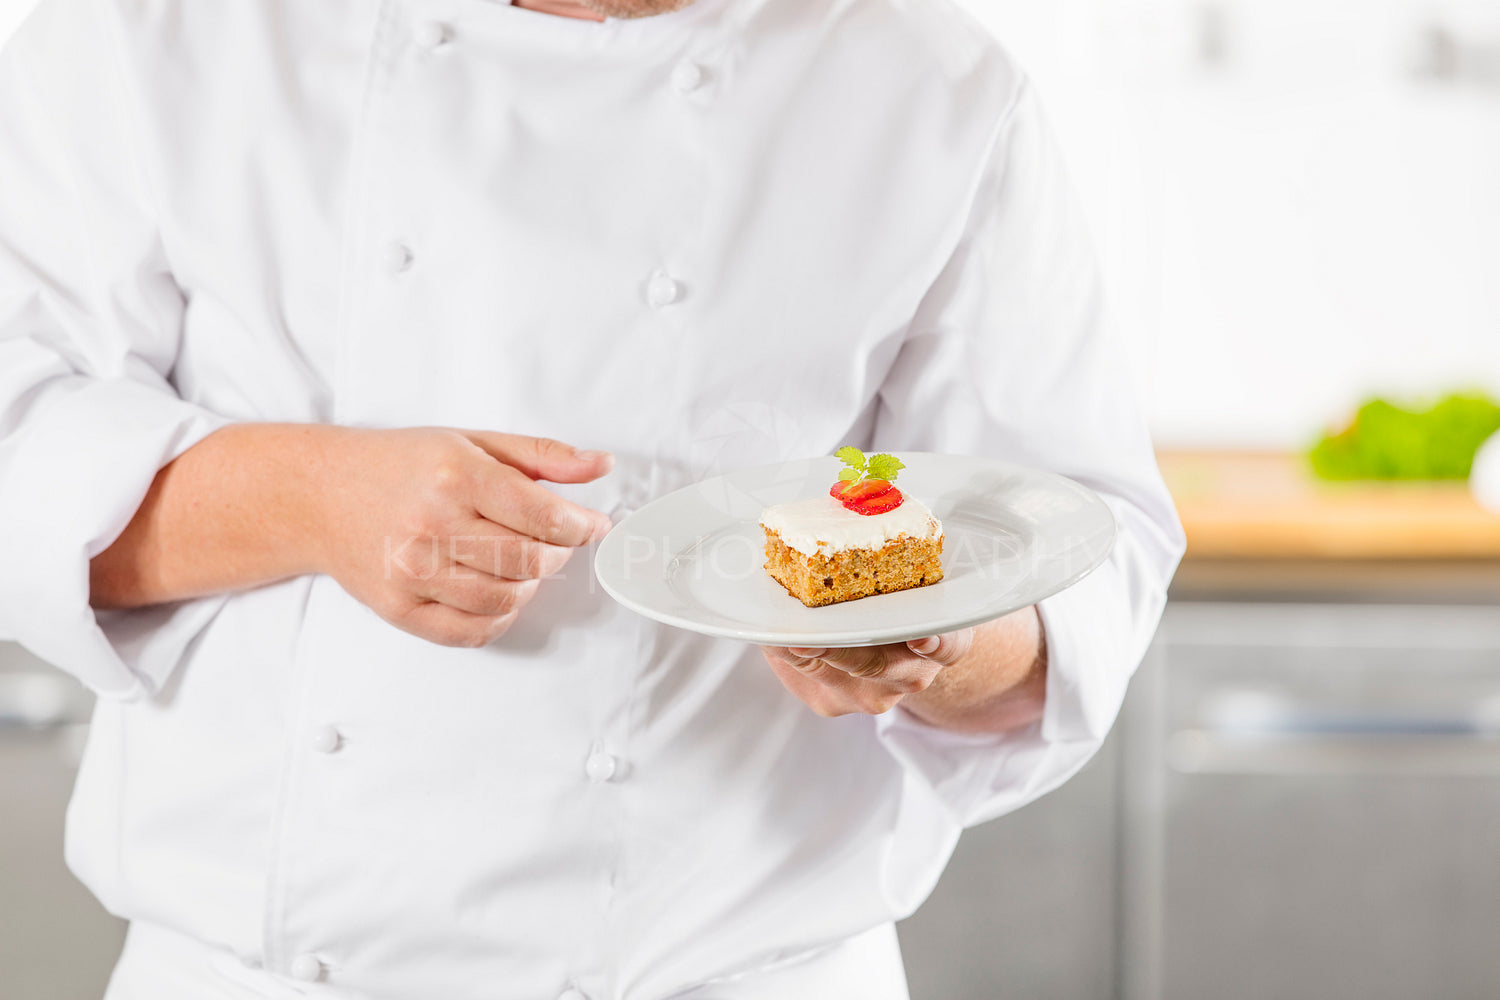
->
xmin=1125 ymin=604 xmax=1500 ymax=1000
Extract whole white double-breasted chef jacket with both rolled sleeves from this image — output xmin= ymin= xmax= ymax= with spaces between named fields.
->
xmin=0 ymin=0 xmax=1182 ymax=1000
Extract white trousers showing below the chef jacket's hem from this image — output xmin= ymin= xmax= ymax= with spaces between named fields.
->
xmin=104 ymin=921 xmax=911 ymax=1000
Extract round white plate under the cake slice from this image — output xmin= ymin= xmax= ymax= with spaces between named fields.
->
xmin=594 ymin=453 xmax=1115 ymax=648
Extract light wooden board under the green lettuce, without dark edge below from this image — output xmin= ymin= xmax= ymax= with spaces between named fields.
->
xmin=1158 ymin=450 xmax=1500 ymax=559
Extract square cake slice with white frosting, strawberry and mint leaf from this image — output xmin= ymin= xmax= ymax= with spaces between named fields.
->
xmin=761 ymin=448 xmax=944 ymax=607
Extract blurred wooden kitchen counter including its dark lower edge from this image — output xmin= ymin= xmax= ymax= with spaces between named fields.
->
xmin=1158 ymin=450 xmax=1500 ymax=603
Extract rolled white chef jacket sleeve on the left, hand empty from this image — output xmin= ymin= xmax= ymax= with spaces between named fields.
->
xmin=0 ymin=0 xmax=227 ymax=699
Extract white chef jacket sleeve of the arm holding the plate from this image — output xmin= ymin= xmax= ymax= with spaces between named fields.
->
xmin=873 ymin=82 xmax=1184 ymax=826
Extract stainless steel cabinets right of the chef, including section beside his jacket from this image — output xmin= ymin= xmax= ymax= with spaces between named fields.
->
xmin=902 ymin=603 xmax=1500 ymax=1000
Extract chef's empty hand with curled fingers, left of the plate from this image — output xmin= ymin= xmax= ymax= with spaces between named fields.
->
xmin=317 ymin=427 xmax=614 ymax=646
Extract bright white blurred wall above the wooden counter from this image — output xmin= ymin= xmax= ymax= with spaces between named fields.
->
xmin=965 ymin=0 xmax=1500 ymax=447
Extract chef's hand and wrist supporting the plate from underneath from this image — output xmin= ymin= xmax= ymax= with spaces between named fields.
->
xmin=761 ymin=607 xmax=1047 ymax=733
